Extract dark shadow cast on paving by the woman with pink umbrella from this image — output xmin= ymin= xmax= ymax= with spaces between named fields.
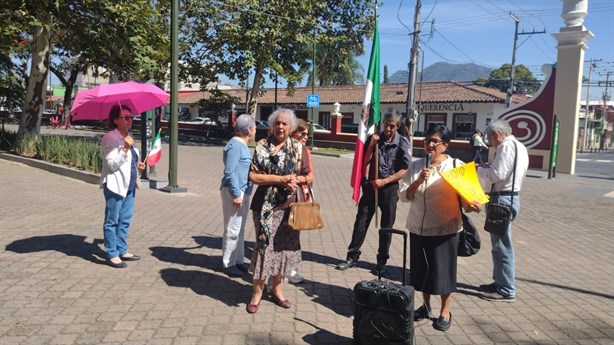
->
xmin=5 ymin=234 xmax=106 ymax=265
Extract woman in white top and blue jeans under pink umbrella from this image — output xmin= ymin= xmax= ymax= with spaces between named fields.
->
xmin=100 ymin=105 xmax=145 ymax=268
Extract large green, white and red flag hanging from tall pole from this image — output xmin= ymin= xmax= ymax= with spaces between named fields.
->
xmin=350 ymin=17 xmax=380 ymax=202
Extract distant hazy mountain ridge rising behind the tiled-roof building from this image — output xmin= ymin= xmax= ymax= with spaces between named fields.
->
xmin=388 ymin=62 xmax=492 ymax=83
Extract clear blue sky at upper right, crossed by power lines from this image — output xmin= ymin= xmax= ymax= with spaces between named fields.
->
xmin=358 ymin=0 xmax=614 ymax=99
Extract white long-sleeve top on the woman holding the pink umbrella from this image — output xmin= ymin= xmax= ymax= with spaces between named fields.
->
xmin=100 ymin=129 xmax=139 ymax=197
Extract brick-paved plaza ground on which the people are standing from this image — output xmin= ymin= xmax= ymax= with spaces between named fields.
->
xmin=0 ymin=127 xmax=614 ymax=345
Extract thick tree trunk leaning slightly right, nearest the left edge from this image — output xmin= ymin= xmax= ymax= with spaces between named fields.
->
xmin=17 ymin=14 xmax=51 ymax=137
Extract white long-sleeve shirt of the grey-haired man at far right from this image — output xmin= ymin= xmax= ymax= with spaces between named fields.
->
xmin=478 ymin=135 xmax=529 ymax=192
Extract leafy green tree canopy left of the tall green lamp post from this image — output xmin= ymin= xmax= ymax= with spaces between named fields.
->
xmin=0 ymin=0 xmax=168 ymax=135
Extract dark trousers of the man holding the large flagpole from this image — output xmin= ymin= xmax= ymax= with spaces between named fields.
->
xmin=347 ymin=181 xmax=399 ymax=265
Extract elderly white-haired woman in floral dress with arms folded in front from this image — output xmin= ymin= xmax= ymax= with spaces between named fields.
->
xmin=246 ymin=109 xmax=311 ymax=314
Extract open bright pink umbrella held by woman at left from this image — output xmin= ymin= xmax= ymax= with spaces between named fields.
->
xmin=70 ymin=81 xmax=170 ymax=121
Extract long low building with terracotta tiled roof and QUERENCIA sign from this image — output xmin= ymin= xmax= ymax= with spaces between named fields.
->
xmin=178 ymin=82 xmax=527 ymax=139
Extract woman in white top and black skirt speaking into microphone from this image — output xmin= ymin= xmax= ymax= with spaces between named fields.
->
xmin=399 ymin=127 xmax=481 ymax=331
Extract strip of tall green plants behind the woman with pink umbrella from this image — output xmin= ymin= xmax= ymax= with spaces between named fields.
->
xmin=0 ymin=131 xmax=102 ymax=173
